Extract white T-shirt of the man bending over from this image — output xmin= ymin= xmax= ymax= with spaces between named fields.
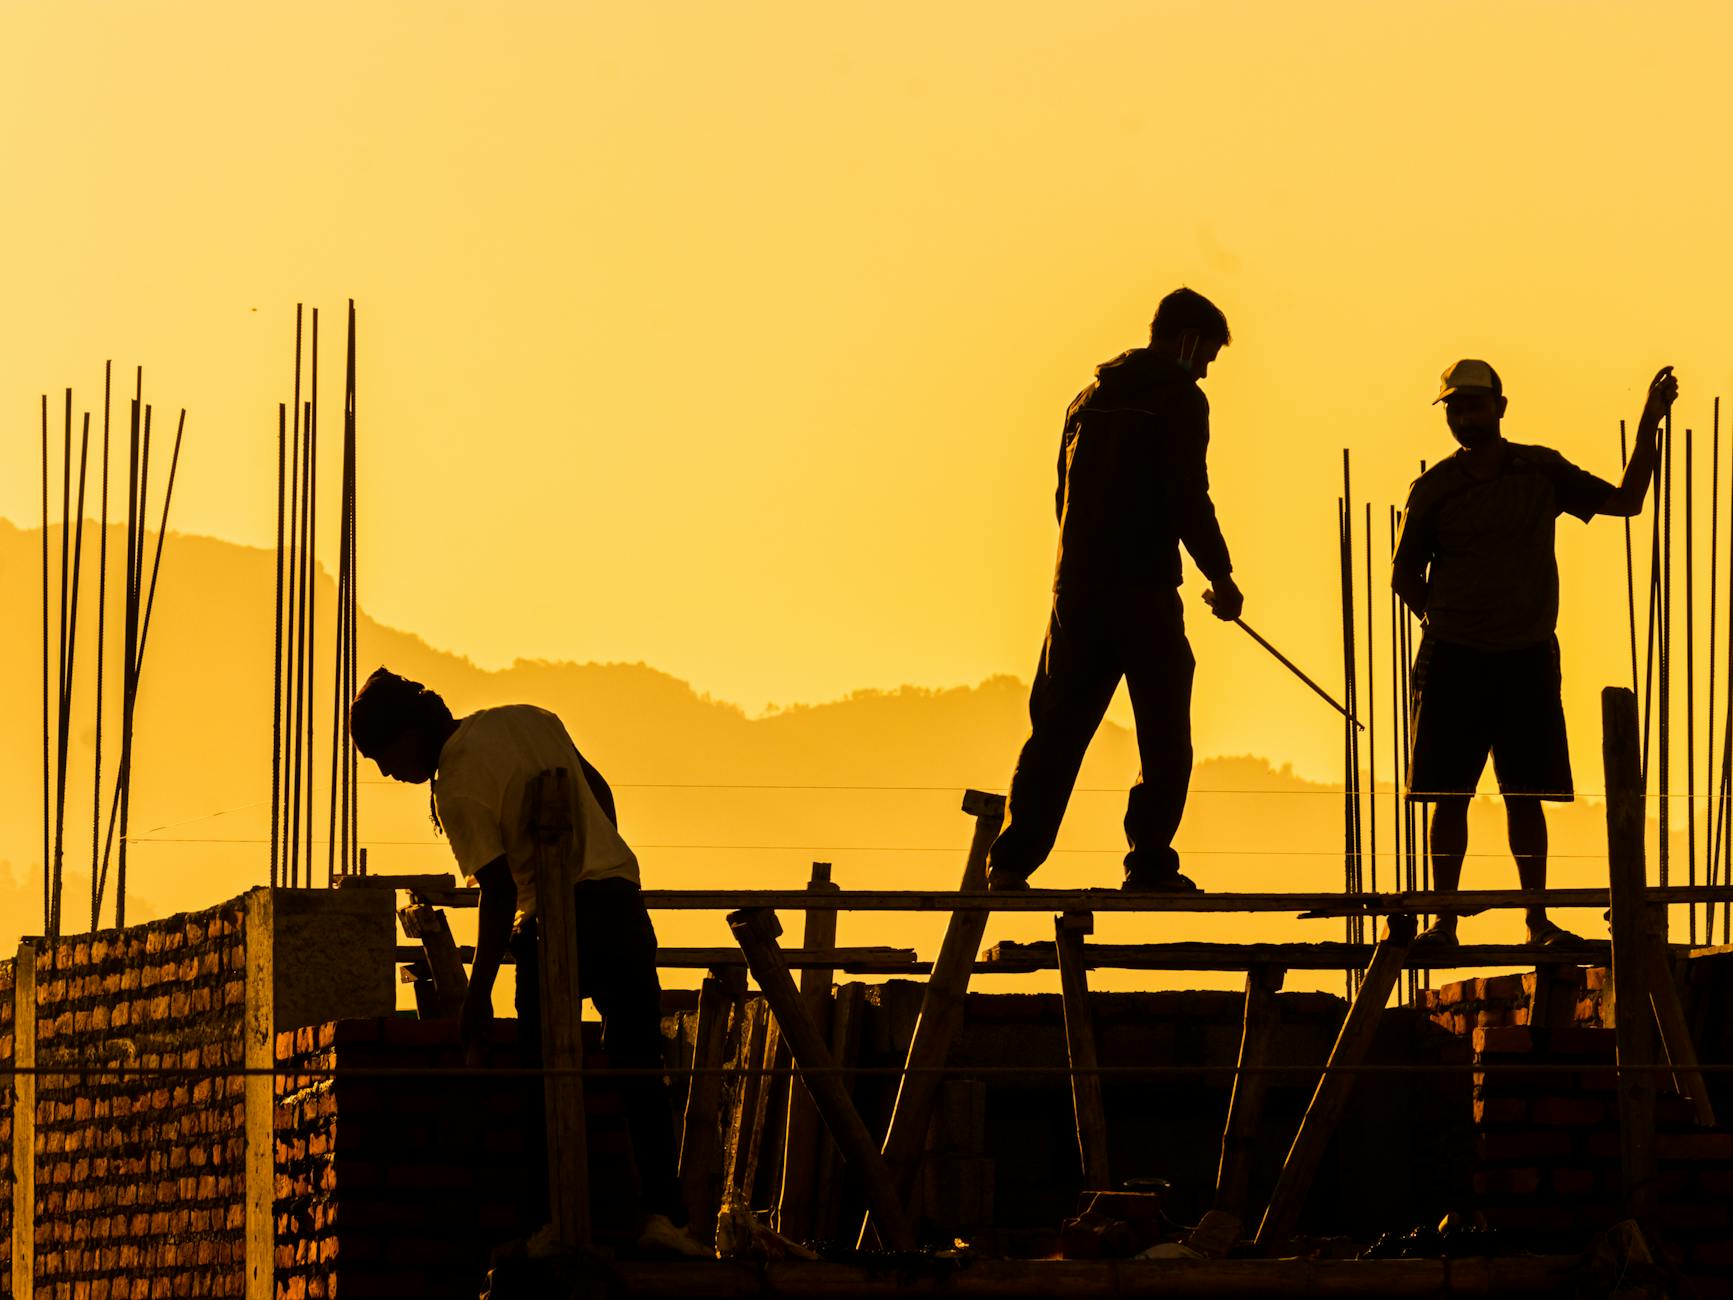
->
xmin=433 ymin=704 xmax=638 ymax=920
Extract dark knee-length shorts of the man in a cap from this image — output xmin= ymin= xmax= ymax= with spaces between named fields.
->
xmin=1407 ymin=636 xmax=1575 ymax=803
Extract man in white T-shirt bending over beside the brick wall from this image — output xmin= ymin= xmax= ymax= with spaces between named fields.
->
xmin=350 ymin=667 xmax=709 ymax=1255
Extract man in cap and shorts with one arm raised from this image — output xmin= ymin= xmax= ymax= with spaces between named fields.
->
xmin=1390 ymin=361 xmax=1679 ymax=946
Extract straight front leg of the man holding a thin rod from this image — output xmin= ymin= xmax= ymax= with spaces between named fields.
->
xmin=1120 ymin=591 xmax=1196 ymax=889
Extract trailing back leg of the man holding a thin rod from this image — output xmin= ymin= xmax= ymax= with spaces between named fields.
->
xmin=988 ymin=600 xmax=1120 ymax=882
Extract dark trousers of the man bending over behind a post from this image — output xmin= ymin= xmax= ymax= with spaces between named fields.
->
xmin=511 ymin=881 xmax=685 ymax=1222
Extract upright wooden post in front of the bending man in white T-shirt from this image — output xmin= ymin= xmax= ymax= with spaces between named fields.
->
xmin=527 ymin=768 xmax=589 ymax=1248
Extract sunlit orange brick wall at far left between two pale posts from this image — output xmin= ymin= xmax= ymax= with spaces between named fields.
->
xmin=23 ymin=903 xmax=246 ymax=1300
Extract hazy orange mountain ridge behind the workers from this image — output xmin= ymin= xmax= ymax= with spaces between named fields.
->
xmin=0 ymin=520 xmax=1642 ymax=983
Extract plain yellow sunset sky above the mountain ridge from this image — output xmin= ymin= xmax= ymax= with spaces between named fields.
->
xmin=0 ymin=0 xmax=1733 ymax=789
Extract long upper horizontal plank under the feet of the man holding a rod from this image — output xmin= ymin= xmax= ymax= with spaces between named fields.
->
xmin=423 ymin=884 xmax=1733 ymax=920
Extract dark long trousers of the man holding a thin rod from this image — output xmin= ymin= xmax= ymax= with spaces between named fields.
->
xmin=988 ymin=589 xmax=1194 ymax=886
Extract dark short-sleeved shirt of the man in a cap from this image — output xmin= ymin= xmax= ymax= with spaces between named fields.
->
xmin=1395 ymin=442 xmax=1613 ymax=650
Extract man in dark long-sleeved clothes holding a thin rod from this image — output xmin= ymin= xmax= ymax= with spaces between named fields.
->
xmin=988 ymin=288 xmax=1243 ymax=893
